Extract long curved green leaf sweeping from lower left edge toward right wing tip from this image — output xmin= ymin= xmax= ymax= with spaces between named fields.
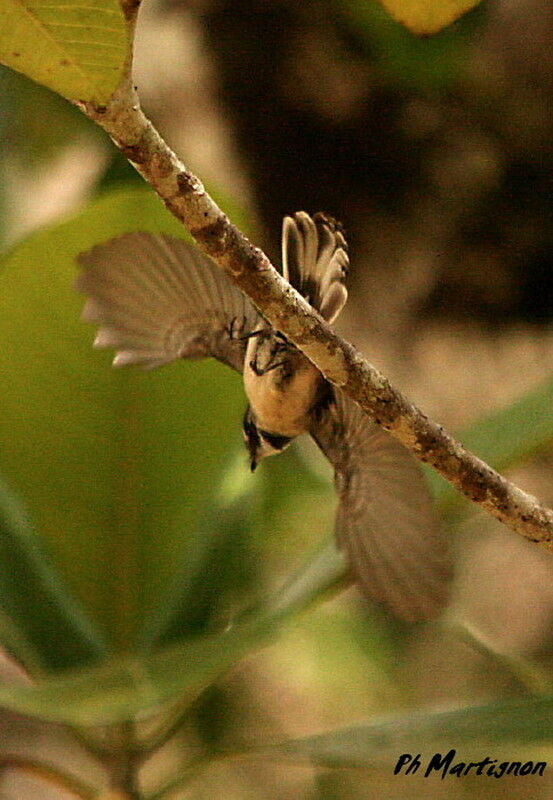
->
xmin=0 ymin=494 xmax=350 ymax=725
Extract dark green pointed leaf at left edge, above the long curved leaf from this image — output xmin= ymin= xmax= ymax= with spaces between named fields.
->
xmin=0 ymin=481 xmax=107 ymax=675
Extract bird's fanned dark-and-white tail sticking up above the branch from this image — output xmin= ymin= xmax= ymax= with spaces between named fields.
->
xmin=282 ymin=211 xmax=349 ymax=322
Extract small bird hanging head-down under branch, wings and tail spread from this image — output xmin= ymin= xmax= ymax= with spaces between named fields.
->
xmin=76 ymin=211 xmax=449 ymax=620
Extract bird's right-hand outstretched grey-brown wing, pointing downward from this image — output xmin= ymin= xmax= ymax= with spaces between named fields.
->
xmin=311 ymin=389 xmax=450 ymax=621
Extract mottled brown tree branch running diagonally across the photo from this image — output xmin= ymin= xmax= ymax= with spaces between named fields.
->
xmin=77 ymin=81 xmax=553 ymax=549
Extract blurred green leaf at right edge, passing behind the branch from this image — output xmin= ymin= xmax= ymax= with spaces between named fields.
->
xmin=427 ymin=379 xmax=553 ymax=507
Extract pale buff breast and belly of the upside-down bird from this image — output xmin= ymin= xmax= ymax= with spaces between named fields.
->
xmin=244 ymin=352 xmax=323 ymax=438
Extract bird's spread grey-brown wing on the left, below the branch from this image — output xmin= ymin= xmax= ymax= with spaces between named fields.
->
xmin=75 ymin=233 xmax=259 ymax=372
